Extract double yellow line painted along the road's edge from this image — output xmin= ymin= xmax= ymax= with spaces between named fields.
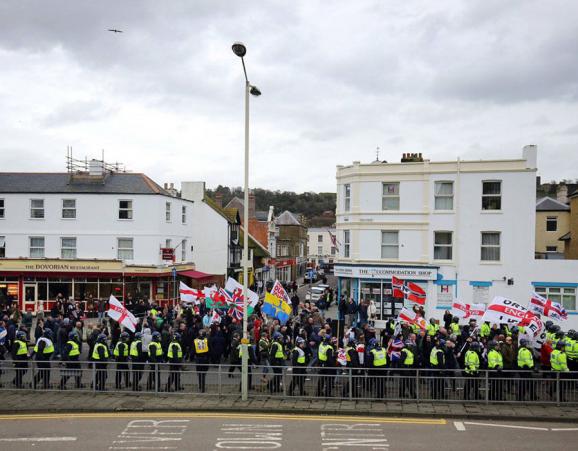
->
xmin=0 ymin=412 xmax=447 ymax=425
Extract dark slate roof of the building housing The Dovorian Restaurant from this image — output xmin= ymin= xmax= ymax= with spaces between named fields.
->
xmin=0 ymin=172 xmax=172 ymax=197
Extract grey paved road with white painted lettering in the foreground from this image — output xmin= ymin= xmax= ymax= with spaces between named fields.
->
xmin=0 ymin=412 xmax=578 ymax=451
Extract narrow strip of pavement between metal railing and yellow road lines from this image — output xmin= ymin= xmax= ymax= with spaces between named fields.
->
xmin=0 ymin=391 xmax=578 ymax=424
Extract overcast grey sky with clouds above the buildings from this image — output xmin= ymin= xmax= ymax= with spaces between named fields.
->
xmin=0 ymin=0 xmax=578 ymax=192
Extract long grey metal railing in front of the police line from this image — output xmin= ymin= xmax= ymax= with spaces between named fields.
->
xmin=0 ymin=360 xmax=578 ymax=405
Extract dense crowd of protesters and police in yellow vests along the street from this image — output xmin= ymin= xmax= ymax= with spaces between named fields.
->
xmin=0 ymin=284 xmax=578 ymax=401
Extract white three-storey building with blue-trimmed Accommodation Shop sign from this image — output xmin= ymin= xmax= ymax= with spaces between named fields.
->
xmin=335 ymin=146 xmax=578 ymax=327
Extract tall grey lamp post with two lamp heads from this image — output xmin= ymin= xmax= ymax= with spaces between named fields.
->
xmin=232 ymin=42 xmax=261 ymax=401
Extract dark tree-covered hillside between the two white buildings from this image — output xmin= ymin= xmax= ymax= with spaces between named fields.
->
xmin=207 ymin=185 xmax=336 ymax=227
